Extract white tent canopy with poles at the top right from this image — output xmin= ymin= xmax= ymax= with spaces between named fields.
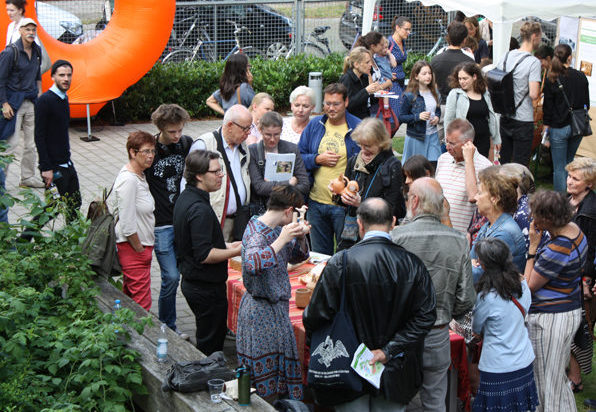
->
xmin=362 ymin=0 xmax=596 ymax=62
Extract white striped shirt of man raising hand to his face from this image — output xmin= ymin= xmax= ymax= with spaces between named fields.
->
xmin=435 ymin=150 xmax=492 ymax=234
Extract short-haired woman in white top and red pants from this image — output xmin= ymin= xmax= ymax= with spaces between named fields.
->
xmin=114 ymin=131 xmax=155 ymax=310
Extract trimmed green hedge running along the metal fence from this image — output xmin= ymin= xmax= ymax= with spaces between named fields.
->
xmin=108 ymin=54 xmax=422 ymax=122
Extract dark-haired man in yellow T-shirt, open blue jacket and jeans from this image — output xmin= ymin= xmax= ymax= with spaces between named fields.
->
xmin=298 ymin=83 xmax=360 ymax=255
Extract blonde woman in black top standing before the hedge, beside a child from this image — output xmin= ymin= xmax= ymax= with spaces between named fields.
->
xmin=339 ymin=46 xmax=381 ymax=119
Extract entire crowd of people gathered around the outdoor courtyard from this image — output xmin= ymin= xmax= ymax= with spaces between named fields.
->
xmin=0 ymin=5 xmax=596 ymax=411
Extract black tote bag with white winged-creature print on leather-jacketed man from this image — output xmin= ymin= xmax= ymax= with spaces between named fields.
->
xmin=308 ymin=251 xmax=362 ymax=392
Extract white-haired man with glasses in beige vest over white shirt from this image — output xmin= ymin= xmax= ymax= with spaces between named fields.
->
xmin=182 ymin=104 xmax=252 ymax=242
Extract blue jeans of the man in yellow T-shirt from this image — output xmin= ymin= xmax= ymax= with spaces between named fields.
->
xmin=306 ymin=200 xmax=346 ymax=255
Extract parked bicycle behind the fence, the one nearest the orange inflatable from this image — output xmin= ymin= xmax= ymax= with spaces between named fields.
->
xmin=162 ymin=19 xmax=263 ymax=64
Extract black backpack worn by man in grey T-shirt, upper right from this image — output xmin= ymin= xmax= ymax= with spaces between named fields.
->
xmin=486 ymin=52 xmax=530 ymax=117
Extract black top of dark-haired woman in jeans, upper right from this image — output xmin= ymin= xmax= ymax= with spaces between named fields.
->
xmin=542 ymin=68 xmax=590 ymax=129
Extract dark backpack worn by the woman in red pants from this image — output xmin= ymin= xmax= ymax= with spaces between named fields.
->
xmin=82 ymin=186 xmax=122 ymax=277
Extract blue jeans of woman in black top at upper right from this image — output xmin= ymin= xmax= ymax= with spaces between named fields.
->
xmin=550 ymin=126 xmax=582 ymax=192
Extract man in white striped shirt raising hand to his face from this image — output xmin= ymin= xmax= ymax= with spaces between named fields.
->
xmin=435 ymin=119 xmax=492 ymax=234
